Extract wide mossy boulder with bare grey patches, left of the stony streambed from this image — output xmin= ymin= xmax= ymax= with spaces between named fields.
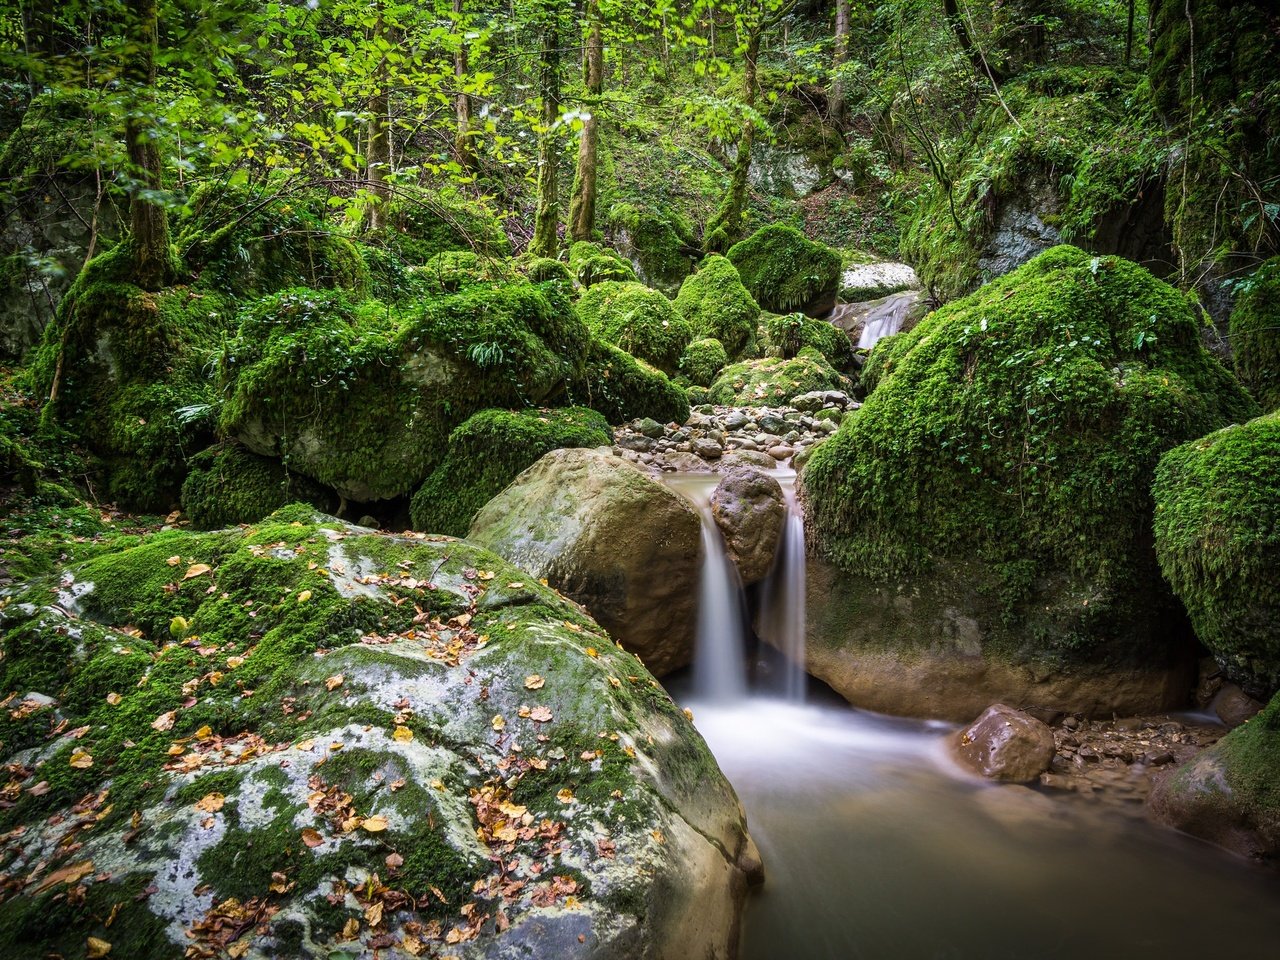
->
xmin=220 ymin=280 xmax=589 ymax=502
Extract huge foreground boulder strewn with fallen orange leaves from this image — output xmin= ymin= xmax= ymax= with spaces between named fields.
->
xmin=0 ymin=507 xmax=754 ymax=960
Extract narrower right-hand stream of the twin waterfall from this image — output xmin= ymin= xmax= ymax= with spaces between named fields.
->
xmin=760 ymin=470 xmax=805 ymax=703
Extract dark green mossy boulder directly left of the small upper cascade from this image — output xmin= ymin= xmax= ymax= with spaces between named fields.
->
xmin=726 ymin=224 xmax=840 ymax=316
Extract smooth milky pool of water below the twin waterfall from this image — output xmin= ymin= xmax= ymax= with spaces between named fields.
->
xmin=675 ymin=689 xmax=1280 ymax=960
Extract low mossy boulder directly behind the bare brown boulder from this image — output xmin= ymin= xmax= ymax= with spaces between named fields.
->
xmin=410 ymin=407 xmax=613 ymax=536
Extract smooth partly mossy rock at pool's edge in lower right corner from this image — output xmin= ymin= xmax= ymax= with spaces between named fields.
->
xmin=1147 ymin=694 xmax=1280 ymax=860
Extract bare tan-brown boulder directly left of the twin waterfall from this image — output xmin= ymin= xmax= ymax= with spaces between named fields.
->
xmin=467 ymin=449 xmax=701 ymax=676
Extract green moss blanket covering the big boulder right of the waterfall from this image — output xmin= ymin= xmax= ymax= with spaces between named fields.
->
xmin=805 ymin=247 xmax=1253 ymax=655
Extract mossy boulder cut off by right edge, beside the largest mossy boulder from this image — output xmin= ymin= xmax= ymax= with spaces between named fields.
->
xmin=1153 ymin=412 xmax=1280 ymax=700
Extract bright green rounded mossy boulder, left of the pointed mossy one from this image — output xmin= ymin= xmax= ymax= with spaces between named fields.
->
xmin=577 ymin=280 xmax=694 ymax=374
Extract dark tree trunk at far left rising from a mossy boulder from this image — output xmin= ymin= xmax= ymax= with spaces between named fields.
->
xmin=124 ymin=0 xmax=177 ymax=291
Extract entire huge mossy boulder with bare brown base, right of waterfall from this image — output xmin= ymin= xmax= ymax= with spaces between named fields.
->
xmin=804 ymin=247 xmax=1254 ymax=719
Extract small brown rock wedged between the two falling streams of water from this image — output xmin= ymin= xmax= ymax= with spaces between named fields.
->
xmin=712 ymin=467 xmax=787 ymax=585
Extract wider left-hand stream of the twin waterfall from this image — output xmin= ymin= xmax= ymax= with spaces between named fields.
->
xmin=666 ymin=474 xmax=746 ymax=704
